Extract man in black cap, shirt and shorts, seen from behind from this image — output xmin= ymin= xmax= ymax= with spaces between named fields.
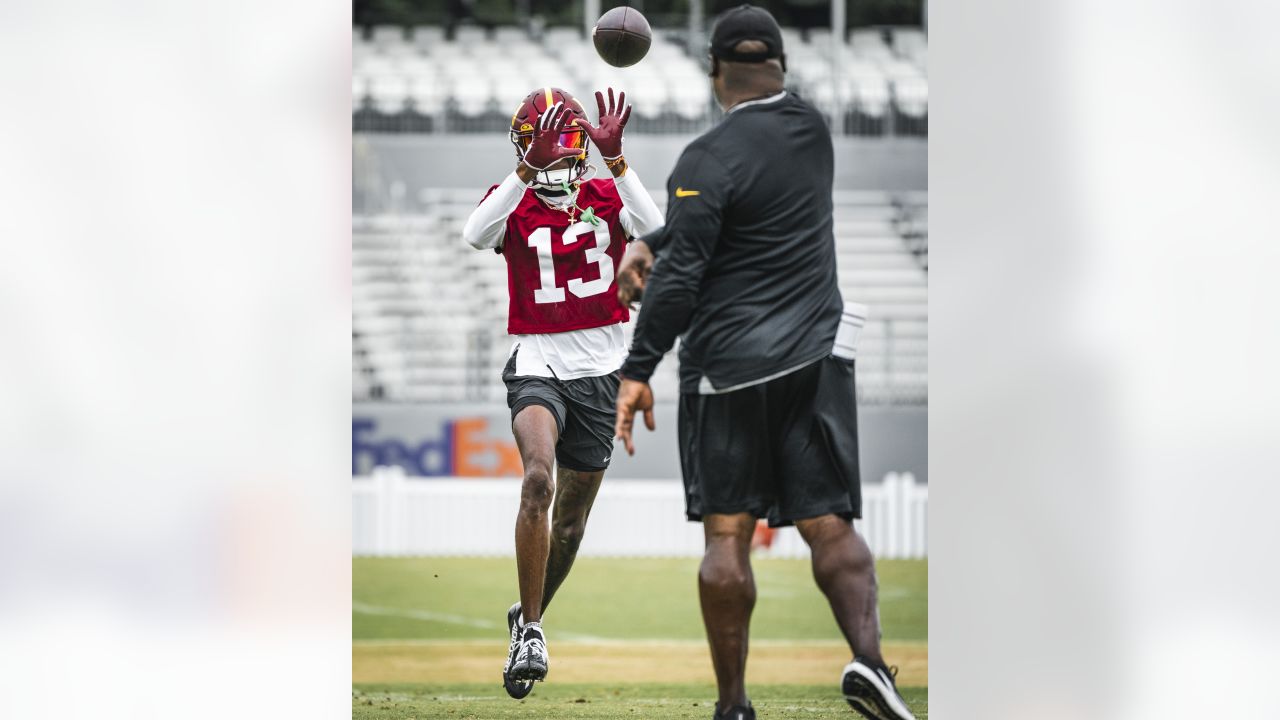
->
xmin=616 ymin=5 xmax=913 ymax=720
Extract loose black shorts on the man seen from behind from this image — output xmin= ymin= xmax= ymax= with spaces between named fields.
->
xmin=680 ymin=356 xmax=861 ymax=528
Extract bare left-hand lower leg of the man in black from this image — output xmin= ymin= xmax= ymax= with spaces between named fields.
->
xmin=698 ymin=512 xmax=755 ymax=710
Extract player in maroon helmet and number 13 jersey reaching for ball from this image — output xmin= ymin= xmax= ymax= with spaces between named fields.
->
xmin=462 ymin=87 xmax=663 ymax=698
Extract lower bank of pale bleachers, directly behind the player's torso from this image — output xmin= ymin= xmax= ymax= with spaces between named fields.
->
xmin=352 ymin=188 xmax=928 ymax=405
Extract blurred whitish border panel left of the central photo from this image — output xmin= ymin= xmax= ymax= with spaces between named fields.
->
xmin=0 ymin=0 xmax=351 ymax=719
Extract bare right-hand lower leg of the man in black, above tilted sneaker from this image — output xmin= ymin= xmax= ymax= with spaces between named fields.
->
xmin=796 ymin=515 xmax=883 ymax=664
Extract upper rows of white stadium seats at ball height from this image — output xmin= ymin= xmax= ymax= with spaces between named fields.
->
xmin=351 ymin=26 xmax=929 ymax=136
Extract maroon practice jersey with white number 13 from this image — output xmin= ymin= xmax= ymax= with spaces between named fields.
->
xmin=485 ymin=179 xmax=630 ymax=334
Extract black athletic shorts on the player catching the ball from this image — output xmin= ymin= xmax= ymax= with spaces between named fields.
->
xmin=502 ymin=348 xmax=622 ymax=473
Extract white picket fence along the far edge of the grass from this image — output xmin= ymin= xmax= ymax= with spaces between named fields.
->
xmin=351 ymin=468 xmax=929 ymax=557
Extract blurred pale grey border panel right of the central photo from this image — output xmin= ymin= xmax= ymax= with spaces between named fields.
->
xmin=929 ymin=0 xmax=1280 ymax=719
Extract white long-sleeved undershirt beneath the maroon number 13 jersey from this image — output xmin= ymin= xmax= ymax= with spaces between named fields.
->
xmin=462 ymin=168 xmax=664 ymax=380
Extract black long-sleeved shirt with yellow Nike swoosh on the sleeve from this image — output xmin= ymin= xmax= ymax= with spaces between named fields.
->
xmin=622 ymin=92 xmax=842 ymax=393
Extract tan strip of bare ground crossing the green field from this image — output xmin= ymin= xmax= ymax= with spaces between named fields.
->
xmin=351 ymin=642 xmax=929 ymax=687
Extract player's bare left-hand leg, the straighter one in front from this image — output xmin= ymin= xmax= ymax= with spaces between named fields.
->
xmin=512 ymin=405 xmax=559 ymax=623
